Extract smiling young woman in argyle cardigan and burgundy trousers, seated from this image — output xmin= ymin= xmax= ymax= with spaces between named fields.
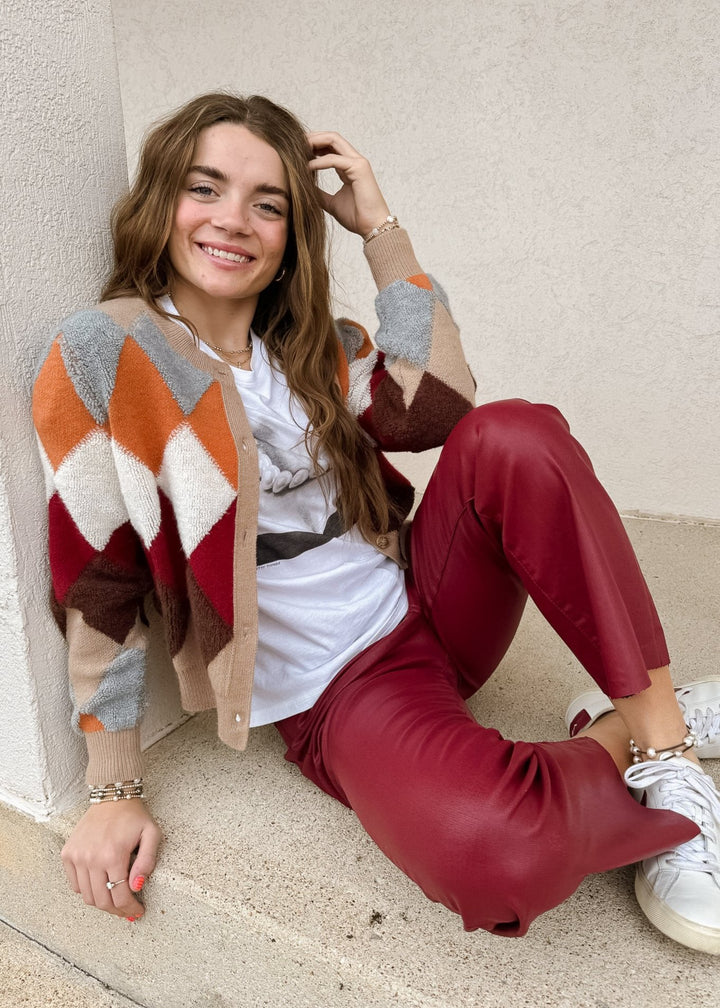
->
xmin=34 ymin=94 xmax=720 ymax=953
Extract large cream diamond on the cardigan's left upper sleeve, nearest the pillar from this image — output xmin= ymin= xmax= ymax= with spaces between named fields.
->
xmin=54 ymin=429 xmax=127 ymax=550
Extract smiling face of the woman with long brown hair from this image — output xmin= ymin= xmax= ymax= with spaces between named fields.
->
xmin=167 ymin=122 xmax=290 ymax=328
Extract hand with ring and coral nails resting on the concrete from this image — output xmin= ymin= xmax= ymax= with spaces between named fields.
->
xmin=61 ymin=798 xmax=161 ymax=919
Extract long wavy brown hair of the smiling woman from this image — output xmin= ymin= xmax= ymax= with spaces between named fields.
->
xmin=102 ymin=92 xmax=397 ymax=538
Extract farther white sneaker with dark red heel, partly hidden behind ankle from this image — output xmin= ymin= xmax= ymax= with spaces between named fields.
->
xmin=565 ymin=675 xmax=720 ymax=759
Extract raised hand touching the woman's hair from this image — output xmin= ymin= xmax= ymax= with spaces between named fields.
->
xmin=308 ymin=133 xmax=390 ymax=235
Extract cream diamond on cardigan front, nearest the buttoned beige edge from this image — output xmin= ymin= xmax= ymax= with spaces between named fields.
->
xmin=157 ymin=423 xmax=235 ymax=556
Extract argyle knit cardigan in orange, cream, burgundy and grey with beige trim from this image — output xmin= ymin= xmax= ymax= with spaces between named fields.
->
xmin=33 ymin=230 xmax=474 ymax=783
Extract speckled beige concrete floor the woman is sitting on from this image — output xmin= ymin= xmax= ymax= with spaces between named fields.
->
xmin=0 ymin=520 xmax=720 ymax=1008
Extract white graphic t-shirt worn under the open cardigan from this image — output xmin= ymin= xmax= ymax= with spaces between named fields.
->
xmin=163 ymin=298 xmax=407 ymax=727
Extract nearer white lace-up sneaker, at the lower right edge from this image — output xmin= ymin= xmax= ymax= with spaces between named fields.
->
xmin=625 ymin=757 xmax=720 ymax=956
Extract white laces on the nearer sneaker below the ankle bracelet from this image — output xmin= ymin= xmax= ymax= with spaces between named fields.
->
xmin=625 ymin=760 xmax=720 ymax=875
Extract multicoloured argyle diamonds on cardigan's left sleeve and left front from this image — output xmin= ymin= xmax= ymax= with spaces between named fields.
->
xmin=34 ymin=310 xmax=237 ymax=745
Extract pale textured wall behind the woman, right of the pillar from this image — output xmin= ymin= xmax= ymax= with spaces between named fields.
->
xmin=114 ymin=0 xmax=720 ymax=519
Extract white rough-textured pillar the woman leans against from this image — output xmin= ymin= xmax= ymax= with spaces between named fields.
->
xmin=0 ymin=0 xmax=136 ymax=814
